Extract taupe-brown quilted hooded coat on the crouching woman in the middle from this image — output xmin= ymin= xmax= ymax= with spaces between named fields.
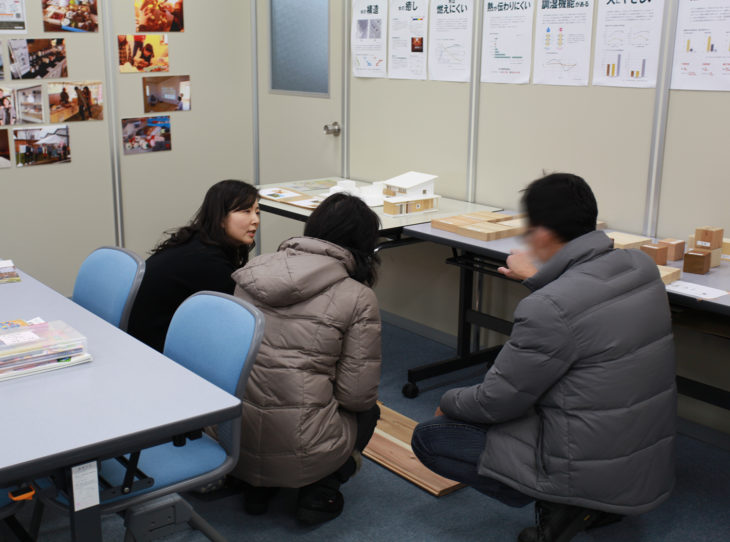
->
xmin=233 ymin=237 xmax=380 ymax=487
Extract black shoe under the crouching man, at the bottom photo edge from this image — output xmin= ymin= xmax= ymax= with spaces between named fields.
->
xmin=517 ymin=501 xmax=603 ymax=542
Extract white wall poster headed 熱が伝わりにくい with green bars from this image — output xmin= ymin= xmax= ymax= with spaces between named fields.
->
xmin=482 ymin=0 xmax=535 ymax=83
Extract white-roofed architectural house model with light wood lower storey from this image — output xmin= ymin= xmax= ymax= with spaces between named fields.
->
xmin=383 ymin=171 xmax=441 ymax=216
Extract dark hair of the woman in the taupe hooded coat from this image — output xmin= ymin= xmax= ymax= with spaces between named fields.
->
xmin=304 ymin=192 xmax=380 ymax=286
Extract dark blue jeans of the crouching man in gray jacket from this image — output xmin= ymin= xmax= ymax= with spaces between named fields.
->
xmin=411 ymin=416 xmax=534 ymax=507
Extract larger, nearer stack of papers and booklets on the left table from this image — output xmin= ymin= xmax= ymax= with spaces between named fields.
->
xmin=0 ymin=320 xmax=91 ymax=380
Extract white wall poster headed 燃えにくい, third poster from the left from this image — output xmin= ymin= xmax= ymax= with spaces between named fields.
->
xmin=428 ymin=0 xmax=474 ymax=82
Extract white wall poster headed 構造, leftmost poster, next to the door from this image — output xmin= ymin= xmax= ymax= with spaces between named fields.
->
xmin=350 ymin=0 xmax=388 ymax=77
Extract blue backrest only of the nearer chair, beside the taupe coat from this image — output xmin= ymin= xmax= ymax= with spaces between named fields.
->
xmin=163 ymin=291 xmax=264 ymax=397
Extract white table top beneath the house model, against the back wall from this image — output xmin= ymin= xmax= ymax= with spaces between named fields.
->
xmin=257 ymin=177 xmax=501 ymax=231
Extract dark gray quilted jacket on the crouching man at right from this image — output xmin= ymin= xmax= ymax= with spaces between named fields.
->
xmin=441 ymin=231 xmax=676 ymax=514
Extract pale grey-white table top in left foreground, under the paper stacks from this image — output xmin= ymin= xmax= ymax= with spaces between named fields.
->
xmin=0 ymin=272 xmax=241 ymax=487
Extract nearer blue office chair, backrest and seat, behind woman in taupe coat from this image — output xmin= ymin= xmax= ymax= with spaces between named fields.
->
xmin=94 ymin=292 xmax=264 ymax=542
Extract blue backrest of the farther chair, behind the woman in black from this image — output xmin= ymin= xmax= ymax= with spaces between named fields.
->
xmin=71 ymin=247 xmax=145 ymax=331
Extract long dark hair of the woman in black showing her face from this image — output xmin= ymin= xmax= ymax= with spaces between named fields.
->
xmin=152 ymin=180 xmax=259 ymax=267
